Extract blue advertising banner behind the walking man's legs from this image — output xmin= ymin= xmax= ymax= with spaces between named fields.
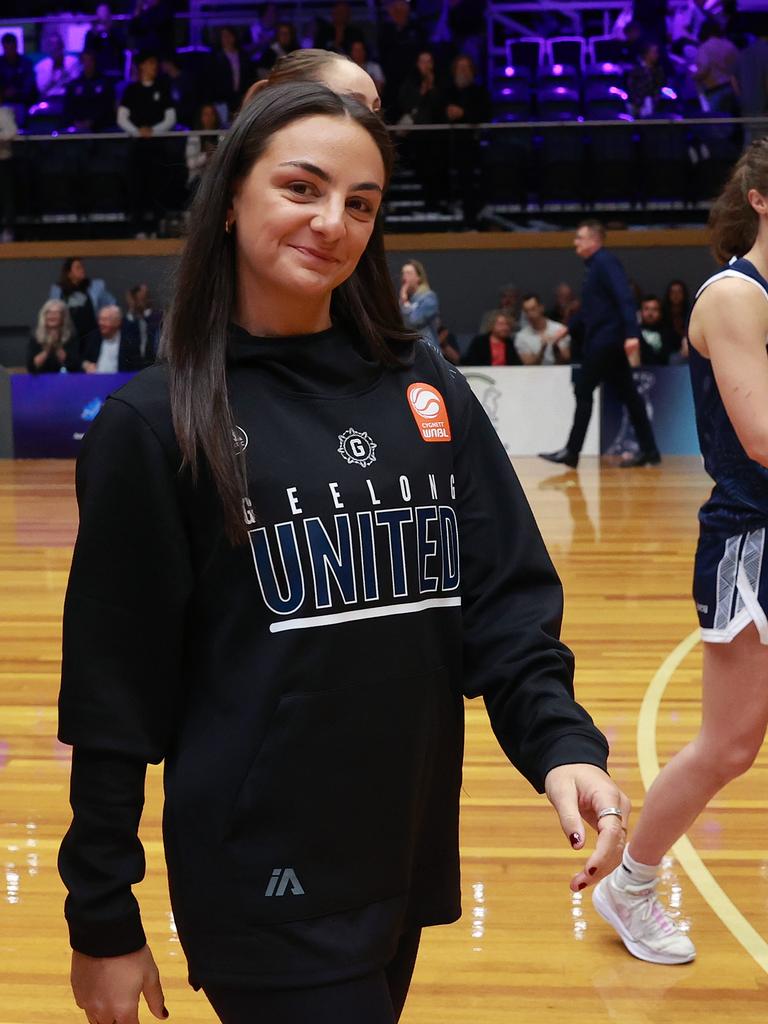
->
xmin=600 ymin=366 xmax=698 ymax=456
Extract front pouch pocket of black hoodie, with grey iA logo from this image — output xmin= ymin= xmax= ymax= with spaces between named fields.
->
xmin=222 ymin=669 xmax=454 ymax=924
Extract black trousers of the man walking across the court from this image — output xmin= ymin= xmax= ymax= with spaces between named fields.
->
xmin=567 ymin=345 xmax=656 ymax=455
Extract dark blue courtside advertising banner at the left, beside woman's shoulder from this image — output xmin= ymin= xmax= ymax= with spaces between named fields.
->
xmin=10 ymin=374 xmax=133 ymax=459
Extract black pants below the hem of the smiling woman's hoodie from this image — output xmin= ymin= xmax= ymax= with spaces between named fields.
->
xmin=205 ymin=929 xmax=421 ymax=1024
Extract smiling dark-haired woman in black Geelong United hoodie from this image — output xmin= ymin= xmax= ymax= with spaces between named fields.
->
xmin=59 ymin=84 xmax=629 ymax=1024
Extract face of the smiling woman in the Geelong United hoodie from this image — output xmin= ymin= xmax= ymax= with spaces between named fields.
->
xmin=230 ymin=115 xmax=385 ymax=303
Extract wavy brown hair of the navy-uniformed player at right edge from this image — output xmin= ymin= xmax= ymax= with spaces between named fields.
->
xmin=710 ymin=138 xmax=768 ymax=263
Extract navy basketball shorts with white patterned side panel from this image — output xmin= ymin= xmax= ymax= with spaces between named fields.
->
xmin=693 ymin=526 xmax=768 ymax=644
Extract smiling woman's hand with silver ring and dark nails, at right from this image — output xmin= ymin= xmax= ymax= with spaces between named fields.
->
xmin=544 ymin=764 xmax=632 ymax=892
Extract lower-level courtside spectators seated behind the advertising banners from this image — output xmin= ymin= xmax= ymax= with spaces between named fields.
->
xmin=27 ymin=257 xmax=690 ymax=374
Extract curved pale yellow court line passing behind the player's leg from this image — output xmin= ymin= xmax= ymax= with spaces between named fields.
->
xmin=637 ymin=630 xmax=768 ymax=974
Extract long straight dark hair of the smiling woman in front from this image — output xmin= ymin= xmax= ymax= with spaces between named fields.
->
xmin=161 ymin=82 xmax=415 ymax=543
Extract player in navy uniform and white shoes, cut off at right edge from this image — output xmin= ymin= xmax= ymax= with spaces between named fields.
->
xmin=594 ymin=139 xmax=768 ymax=964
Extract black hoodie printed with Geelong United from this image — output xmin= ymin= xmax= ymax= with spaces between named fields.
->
xmin=59 ymin=328 xmax=607 ymax=986
